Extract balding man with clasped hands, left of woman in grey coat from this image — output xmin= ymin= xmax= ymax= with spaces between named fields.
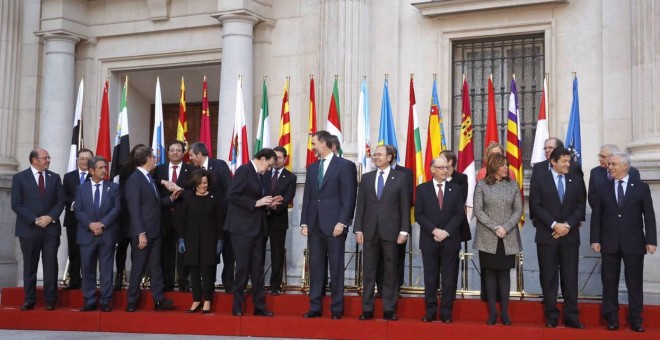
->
xmin=415 ymin=156 xmax=465 ymax=323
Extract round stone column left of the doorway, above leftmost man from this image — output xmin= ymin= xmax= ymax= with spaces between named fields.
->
xmin=37 ymin=34 xmax=80 ymax=176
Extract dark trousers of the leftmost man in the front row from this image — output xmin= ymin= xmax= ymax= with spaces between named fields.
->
xmin=18 ymin=233 xmax=60 ymax=304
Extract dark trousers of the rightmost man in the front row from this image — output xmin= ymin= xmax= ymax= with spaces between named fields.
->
xmin=600 ymin=252 xmax=644 ymax=327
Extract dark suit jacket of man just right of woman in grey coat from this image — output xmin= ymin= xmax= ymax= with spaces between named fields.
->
xmin=529 ymin=170 xmax=586 ymax=244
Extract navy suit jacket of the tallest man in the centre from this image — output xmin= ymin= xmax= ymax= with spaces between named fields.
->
xmin=300 ymin=156 xmax=357 ymax=236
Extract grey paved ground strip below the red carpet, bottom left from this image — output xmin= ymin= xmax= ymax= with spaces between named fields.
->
xmin=0 ymin=329 xmax=306 ymax=340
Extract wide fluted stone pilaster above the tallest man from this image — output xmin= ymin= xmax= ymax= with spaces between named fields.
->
xmin=317 ymin=0 xmax=377 ymax=159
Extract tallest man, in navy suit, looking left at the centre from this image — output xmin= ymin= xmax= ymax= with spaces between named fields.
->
xmin=300 ymin=130 xmax=357 ymax=320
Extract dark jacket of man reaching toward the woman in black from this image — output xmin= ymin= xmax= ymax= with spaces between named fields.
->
xmin=125 ymin=169 xmax=174 ymax=238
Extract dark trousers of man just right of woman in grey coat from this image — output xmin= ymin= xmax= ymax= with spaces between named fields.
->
xmin=536 ymin=243 xmax=580 ymax=322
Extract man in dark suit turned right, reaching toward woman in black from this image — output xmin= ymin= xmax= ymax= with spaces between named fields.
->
xmin=126 ymin=146 xmax=182 ymax=312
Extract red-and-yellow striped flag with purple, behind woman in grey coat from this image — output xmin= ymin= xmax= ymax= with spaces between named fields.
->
xmin=506 ymin=76 xmax=525 ymax=212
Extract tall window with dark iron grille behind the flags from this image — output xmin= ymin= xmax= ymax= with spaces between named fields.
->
xmin=452 ymin=33 xmax=545 ymax=169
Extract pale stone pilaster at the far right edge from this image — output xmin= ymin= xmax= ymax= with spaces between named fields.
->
xmin=627 ymin=0 xmax=660 ymax=304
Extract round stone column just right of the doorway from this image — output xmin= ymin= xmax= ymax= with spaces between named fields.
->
xmin=217 ymin=14 xmax=259 ymax=159
